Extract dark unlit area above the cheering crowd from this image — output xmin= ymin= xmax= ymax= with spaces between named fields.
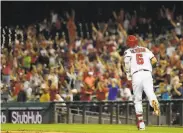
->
xmin=1 ymin=1 xmax=183 ymax=26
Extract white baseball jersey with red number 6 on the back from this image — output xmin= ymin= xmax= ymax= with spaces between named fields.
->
xmin=124 ymin=46 xmax=154 ymax=76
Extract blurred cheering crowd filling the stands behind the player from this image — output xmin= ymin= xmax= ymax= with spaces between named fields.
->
xmin=0 ymin=1 xmax=183 ymax=102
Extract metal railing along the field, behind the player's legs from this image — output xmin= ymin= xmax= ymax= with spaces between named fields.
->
xmin=54 ymin=99 xmax=183 ymax=126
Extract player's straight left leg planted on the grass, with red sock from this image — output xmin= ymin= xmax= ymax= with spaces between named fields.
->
xmin=132 ymin=74 xmax=145 ymax=130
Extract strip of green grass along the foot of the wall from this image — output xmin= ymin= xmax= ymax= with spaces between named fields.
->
xmin=1 ymin=124 xmax=183 ymax=133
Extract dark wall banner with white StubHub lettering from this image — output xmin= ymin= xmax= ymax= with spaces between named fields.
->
xmin=0 ymin=103 xmax=54 ymax=124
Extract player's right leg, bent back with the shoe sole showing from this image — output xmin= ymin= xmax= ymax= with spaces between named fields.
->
xmin=143 ymin=72 xmax=160 ymax=116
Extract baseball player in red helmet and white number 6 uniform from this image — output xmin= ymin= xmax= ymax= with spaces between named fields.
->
xmin=124 ymin=35 xmax=160 ymax=130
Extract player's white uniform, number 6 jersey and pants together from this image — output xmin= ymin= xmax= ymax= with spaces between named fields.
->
xmin=124 ymin=46 xmax=158 ymax=114
